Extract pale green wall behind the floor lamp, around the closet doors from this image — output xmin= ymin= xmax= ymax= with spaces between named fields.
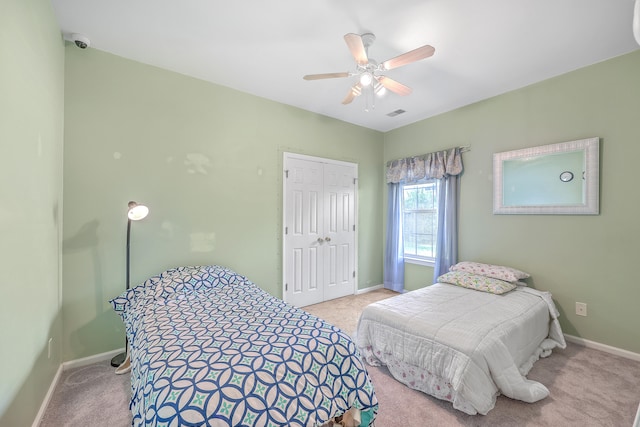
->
xmin=63 ymin=48 xmax=383 ymax=360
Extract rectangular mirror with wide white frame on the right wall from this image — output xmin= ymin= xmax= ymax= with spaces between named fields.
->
xmin=493 ymin=137 xmax=600 ymax=215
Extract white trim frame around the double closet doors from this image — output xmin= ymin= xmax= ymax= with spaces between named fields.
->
xmin=280 ymin=151 xmax=360 ymax=302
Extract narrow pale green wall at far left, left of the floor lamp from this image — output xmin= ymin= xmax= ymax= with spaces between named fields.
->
xmin=0 ymin=0 xmax=64 ymax=427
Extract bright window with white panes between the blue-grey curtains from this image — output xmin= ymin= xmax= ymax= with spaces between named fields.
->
xmin=402 ymin=180 xmax=438 ymax=265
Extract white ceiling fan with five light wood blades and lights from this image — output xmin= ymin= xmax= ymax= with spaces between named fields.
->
xmin=303 ymin=33 xmax=435 ymax=105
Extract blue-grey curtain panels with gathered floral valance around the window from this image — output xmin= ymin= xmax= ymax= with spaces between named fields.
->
xmin=384 ymin=147 xmax=463 ymax=292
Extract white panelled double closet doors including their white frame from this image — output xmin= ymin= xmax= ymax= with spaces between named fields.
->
xmin=283 ymin=155 xmax=357 ymax=307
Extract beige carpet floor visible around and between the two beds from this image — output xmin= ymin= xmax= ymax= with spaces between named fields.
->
xmin=40 ymin=289 xmax=640 ymax=427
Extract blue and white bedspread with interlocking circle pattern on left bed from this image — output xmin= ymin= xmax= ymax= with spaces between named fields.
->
xmin=111 ymin=266 xmax=378 ymax=427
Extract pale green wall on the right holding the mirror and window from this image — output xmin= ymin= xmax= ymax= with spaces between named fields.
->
xmin=384 ymin=51 xmax=640 ymax=353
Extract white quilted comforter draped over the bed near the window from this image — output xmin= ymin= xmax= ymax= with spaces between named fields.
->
xmin=356 ymin=283 xmax=566 ymax=415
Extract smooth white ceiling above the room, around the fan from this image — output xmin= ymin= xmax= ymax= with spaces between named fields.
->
xmin=52 ymin=0 xmax=639 ymax=131
